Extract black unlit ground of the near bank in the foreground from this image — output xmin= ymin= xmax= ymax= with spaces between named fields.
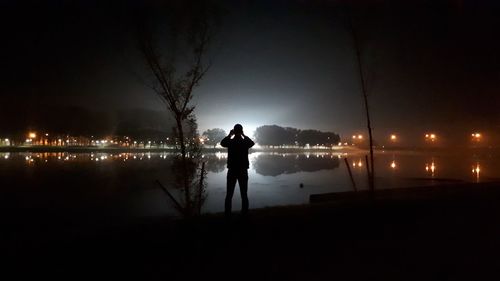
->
xmin=0 ymin=184 xmax=500 ymax=280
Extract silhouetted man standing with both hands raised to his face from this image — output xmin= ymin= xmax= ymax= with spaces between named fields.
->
xmin=220 ymin=124 xmax=255 ymax=217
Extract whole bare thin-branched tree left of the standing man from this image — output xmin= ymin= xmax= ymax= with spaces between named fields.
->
xmin=138 ymin=1 xmax=217 ymax=216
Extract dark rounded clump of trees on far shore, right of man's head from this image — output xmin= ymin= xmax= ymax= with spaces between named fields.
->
xmin=254 ymin=125 xmax=340 ymax=146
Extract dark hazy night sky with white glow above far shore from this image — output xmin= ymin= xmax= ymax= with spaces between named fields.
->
xmin=0 ymin=0 xmax=500 ymax=142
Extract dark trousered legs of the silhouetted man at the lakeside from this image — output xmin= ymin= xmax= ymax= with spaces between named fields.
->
xmin=224 ymin=169 xmax=248 ymax=215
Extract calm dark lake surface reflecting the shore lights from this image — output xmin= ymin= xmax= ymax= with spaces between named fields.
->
xmin=0 ymin=150 xmax=500 ymax=220
